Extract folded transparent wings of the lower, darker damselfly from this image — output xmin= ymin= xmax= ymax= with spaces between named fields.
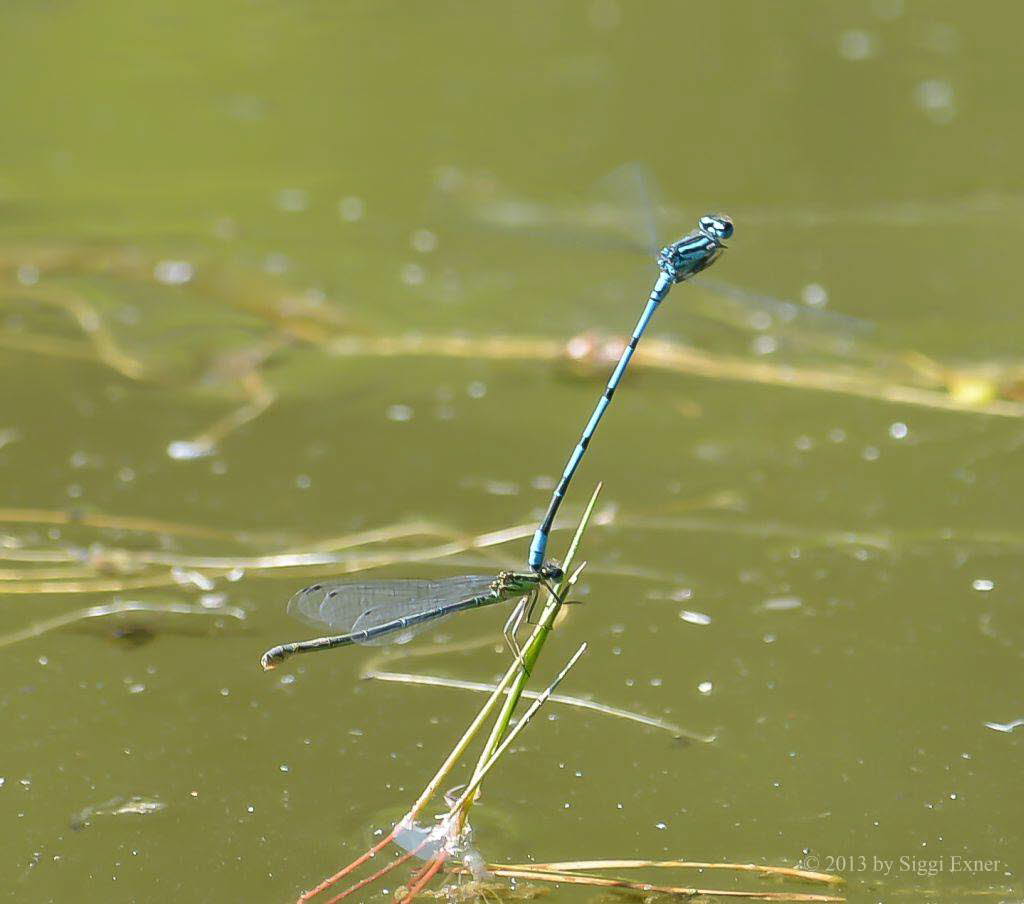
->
xmin=288 ymin=574 xmax=495 ymax=643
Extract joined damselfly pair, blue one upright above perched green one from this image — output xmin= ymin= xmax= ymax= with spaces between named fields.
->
xmin=260 ymin=214 xmax=733 ymax=670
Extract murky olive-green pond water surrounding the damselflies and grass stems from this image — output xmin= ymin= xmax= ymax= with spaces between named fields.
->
xmin=0 ymin=0 xmax=1024 ymax=901
